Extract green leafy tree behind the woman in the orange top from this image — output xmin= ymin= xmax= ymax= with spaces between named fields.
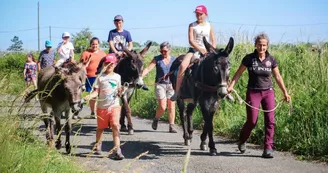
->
xmin=72 ymin=28 xmax=92 ymax=53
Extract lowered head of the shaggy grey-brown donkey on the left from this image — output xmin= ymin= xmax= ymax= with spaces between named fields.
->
xmin=56 ymin=63 xmax=86 ymax=112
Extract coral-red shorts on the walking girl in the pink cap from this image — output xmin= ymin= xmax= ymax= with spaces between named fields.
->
xmin=97 ymin=106 xmax=121 ymax=129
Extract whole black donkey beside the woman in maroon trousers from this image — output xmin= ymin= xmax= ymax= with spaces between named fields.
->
xmin=170 ymin=37 xmax=234 ymax=155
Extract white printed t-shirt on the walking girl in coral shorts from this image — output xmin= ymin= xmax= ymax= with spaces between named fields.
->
xmin=94 ymin=73 xmax=121 ymax=109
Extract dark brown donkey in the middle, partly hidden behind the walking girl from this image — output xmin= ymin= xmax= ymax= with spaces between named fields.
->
xmin=114 ymin=42 xmax=152 ymax=135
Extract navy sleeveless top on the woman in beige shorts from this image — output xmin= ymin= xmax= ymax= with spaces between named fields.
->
xmin=154 ymin=55 xmax=175 ymax=84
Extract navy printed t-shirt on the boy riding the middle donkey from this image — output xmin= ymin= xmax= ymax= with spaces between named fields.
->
xmin=107 ymin=29 xmax=132 ymax=53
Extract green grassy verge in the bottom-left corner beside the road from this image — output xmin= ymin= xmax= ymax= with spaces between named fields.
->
xmin=0 ymin=116 xmax=83 ymax=173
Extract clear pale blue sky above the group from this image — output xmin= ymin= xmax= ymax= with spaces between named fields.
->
xmin=0 ymin=0 xmax=328 ymax=51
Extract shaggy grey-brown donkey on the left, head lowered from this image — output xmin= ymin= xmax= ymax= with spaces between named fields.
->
xmin=25 ymin=62 xmax=86 ymax=154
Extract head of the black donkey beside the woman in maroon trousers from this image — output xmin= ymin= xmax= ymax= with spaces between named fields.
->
xmin=203 ymin=37 xmax=234 ymax=98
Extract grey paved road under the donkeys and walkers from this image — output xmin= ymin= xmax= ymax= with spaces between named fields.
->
xmin=7 ymin=98 xmax=328 ymax=173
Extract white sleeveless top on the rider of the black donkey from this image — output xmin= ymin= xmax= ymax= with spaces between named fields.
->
xmin=191 ymin=22 xmax=211 ymax=48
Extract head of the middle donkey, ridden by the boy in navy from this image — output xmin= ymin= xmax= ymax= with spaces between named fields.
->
xmin=121 ymin=42 xmax=152 ymax=88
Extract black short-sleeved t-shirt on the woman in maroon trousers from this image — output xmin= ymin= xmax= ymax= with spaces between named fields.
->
xmin=242 ymin=50 xmax=277 ymax=90
